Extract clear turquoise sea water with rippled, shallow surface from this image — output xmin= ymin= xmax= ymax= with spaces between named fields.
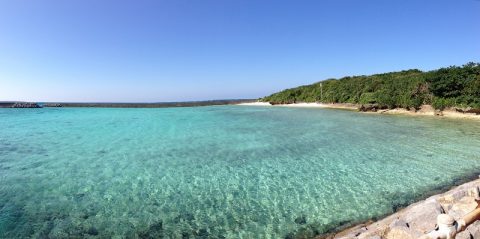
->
xmin=0 ymin=106 xmax=480 ymax=238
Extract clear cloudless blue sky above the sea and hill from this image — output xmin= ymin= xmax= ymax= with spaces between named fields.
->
xmin=0 ymin=0 xmax=480 ymax=102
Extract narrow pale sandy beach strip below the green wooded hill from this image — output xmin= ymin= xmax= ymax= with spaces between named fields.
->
xmin=237 ymin=101 xmax=480 ymax=120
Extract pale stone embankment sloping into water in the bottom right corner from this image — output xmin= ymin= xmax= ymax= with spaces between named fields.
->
xmin=317 ymin=179 xmax=480 ymax=239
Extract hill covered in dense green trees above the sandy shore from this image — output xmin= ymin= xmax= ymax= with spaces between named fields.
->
xmin=261 ymin=63 xmax=480 ymax=110
